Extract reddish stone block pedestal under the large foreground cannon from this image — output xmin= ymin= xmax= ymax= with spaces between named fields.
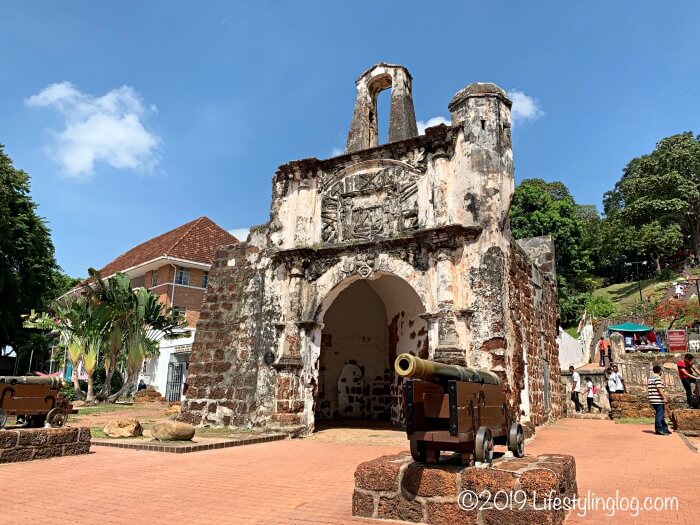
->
xmin=352 ymin=453 xmax=578 ymax=525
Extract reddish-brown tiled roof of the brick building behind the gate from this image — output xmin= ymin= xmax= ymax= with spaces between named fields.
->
xmin=100 ymin=217 xmax=238 ymax=277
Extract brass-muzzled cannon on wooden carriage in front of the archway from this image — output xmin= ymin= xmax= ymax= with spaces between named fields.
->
xmin=394 ymin=354 xmax=525 ymax=464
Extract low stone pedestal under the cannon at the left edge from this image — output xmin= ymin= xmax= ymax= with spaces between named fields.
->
xmin=0 ymin=427 xmax=91 ymax=463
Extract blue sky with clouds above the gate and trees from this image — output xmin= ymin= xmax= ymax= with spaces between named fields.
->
xmin=0 ymin=0 xmax=700 ymax=276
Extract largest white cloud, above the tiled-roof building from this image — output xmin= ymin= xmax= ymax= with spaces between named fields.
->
xmin=25 ymin=82 xmax=160 ymax=179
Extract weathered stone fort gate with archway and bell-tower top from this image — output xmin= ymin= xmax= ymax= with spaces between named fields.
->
xmin=181 ymin=63 xmax=561 ymax=433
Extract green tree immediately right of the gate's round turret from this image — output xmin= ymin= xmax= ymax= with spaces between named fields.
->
xmin=509 ymin=179 xmax=597 ymax=324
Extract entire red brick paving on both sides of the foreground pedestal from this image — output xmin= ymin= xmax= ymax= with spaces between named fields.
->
xmin=0 ymin=420 xmax=700 ymax=525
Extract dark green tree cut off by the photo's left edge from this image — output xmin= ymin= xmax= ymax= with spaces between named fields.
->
xmin=0 ymin=145 xmax=58 ymax=355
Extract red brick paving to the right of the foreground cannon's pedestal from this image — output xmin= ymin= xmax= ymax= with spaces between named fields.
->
xmin=526 ymin=419 xmax=700 ymax=525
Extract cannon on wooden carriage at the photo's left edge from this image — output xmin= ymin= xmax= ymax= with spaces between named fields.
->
xmin=0 ymin=376 xmax=78 ymax=429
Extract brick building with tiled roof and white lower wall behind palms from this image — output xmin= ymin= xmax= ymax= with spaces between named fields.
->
xmin=94 ymin=217 xmax=238 ymax=401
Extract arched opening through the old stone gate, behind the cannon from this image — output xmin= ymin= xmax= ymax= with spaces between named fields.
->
xmin=314 ymin=274 xmax=428 ymax=424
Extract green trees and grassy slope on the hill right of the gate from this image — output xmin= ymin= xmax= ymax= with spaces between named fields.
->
xmin=510 ymin=132 xmax=700 ymax=326
